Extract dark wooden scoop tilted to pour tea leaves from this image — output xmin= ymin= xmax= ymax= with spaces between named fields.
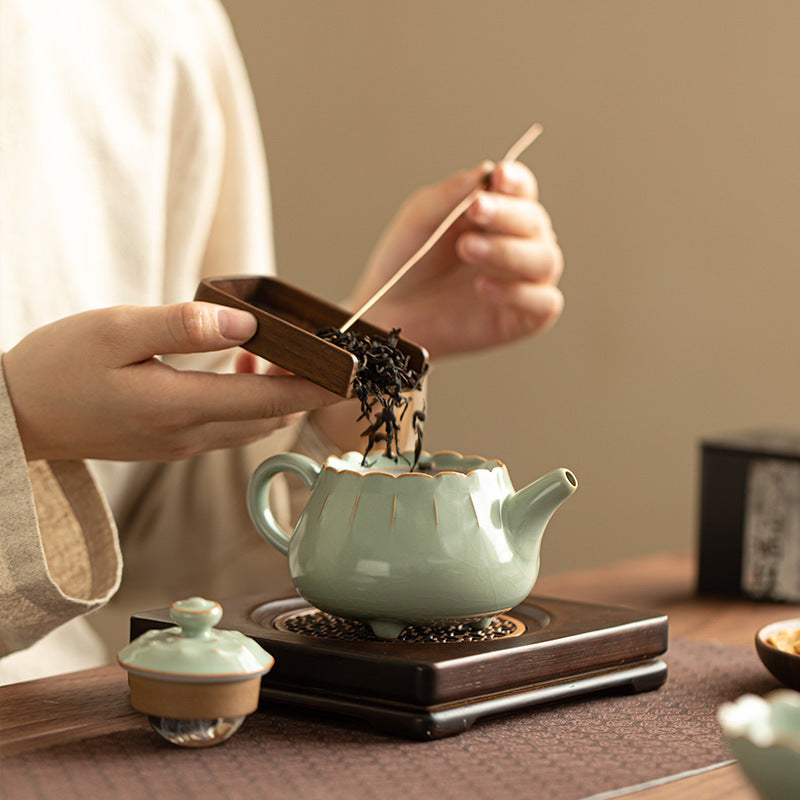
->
xmin=195 ymin=276 xmax=428 ymax=397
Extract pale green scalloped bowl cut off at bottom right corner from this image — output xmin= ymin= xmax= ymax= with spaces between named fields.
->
xmin=717 ymin=689 xmax=800 ymax=800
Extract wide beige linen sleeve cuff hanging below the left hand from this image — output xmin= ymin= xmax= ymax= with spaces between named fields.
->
xmin=0 ymin=362 xmax=122 ymax=656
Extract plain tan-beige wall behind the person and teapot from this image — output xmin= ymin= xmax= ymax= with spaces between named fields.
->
xmin=225 ymin=0 xmax=800 ymax=572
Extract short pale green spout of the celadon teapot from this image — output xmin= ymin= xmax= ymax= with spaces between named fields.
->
xmin=502 ymin=467 xmax=578 ymax=570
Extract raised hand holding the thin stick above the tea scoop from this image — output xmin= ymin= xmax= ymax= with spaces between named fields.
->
xmin=349 ymin=162 xmax=564 ymax=357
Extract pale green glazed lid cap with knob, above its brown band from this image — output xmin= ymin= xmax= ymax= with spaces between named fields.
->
xmin=117 ymin=597 xmax=275 ymax=681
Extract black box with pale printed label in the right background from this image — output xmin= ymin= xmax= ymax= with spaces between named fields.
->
xmin=697 ymin=431 xmax=800 ymax=602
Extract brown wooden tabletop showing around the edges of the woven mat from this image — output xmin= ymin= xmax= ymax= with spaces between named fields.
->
xmin=0 ymin=555 xmax=800 ymax=800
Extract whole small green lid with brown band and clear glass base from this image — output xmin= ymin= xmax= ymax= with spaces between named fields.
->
xmin=117 ymin=597 xmax=275 ymax=747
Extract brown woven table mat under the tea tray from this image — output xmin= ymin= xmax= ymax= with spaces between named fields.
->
xmin=0 ymin=640 xmax=778 ymax=800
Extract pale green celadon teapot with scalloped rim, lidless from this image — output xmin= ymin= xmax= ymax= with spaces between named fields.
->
xmin=247 ymin=452 xmax=578 ymax=639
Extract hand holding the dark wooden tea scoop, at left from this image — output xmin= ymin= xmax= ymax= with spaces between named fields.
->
xmin=2 ymin=302 xmax=341 ymax=461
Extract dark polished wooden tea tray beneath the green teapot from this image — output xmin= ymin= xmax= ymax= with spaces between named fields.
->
xmin=131 ymin=596 xmax=668 ymax=739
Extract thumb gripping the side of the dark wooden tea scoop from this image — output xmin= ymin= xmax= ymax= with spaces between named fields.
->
xmin=100 ymin=301 xmax=256 ymax=366
